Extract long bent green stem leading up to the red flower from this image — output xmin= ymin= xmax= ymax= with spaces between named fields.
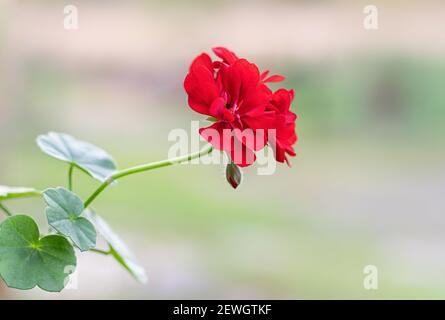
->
xmin=85 ymin=145 xmax=213 ymax=208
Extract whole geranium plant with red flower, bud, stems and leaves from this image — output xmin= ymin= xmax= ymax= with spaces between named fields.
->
xmin=0 ymin=47 xmax=297 ymax=292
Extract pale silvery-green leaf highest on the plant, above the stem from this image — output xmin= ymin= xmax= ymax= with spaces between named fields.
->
xmin=37 ymin=132 xmax=116 ymax=182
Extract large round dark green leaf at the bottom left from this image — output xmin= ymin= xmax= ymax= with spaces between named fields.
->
xmin=0 ymin=215 xmax=76 ymax=292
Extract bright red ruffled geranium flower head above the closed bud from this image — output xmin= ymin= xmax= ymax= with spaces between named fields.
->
xmin=184 ymin=47 xmax=297 ymax=167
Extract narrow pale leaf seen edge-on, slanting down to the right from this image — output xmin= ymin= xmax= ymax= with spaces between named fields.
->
xmin=85 ymin=209 xmax=147 ymax=283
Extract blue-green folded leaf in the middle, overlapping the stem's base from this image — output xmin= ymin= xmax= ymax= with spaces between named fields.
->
xmin=43 ymin=188 xmax=97 ymax=251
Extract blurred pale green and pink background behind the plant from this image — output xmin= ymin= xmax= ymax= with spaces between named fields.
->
xmin=0 ymin=0 xmax=445 ymax=299
